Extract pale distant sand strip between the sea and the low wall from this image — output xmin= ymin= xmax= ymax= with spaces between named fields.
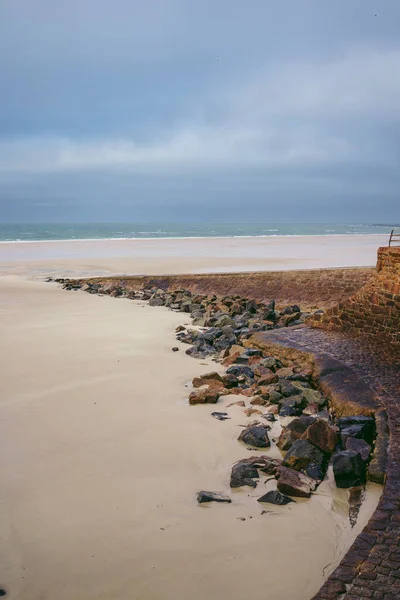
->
xmin=0 ymin=235 xmax=387 ymax=278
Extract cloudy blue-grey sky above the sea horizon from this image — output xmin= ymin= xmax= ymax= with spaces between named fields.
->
xmin=0 ymin=0 xmax=400 ymax=223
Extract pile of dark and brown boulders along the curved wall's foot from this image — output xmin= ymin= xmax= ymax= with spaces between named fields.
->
xmin=56 ymin=279 xmax=375 ymax=505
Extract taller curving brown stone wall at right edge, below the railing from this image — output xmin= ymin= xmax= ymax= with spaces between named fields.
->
xmin=309 ymin=247 xmax=400 ymax=360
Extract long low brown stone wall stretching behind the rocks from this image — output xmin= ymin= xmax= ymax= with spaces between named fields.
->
xmin=83 ymin=267 xmax=374 ymax=309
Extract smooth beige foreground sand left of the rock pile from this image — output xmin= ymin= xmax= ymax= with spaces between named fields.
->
xmin=0 ymin=276 xmax=381 ymax=600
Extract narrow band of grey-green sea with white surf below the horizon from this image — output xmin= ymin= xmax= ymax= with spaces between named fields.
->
xmin=0 ymin=223 xmax=394 ymax=242
